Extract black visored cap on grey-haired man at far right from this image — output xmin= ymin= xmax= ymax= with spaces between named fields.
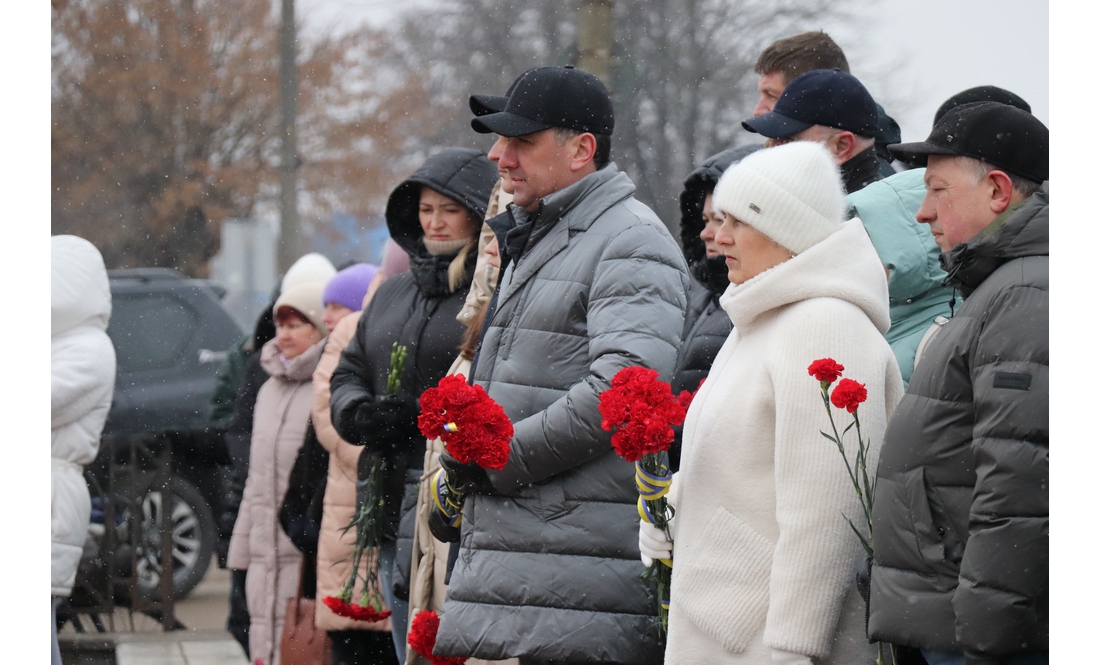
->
xmin=890 ymin=101 xmax=1051 ymax=182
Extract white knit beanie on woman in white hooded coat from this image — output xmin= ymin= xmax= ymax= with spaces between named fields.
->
xmin=714 ymin=141 xmax=846 ymax=254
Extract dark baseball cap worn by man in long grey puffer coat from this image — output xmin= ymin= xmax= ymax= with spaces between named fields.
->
xmin=470 ymin=65 xmax=615 ymax=136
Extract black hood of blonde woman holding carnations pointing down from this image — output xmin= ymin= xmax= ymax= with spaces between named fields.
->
xmin=386 ymin=147 xmax=498 ymax=297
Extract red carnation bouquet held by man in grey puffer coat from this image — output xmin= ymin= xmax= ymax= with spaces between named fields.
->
xmin=417 ymin=374 xmax=515 ymax=527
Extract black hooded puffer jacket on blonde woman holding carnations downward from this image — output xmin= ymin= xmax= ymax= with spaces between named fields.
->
xmin=330 ymin=148 xmax=497 ymax=589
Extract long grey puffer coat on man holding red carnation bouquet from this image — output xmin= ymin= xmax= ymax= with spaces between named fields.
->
xmin=435 ymin=165 xmax=689 ymax=664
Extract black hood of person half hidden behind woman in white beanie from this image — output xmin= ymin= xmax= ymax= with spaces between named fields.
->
xmin=680 ymin=145 xmax=763 ymax=295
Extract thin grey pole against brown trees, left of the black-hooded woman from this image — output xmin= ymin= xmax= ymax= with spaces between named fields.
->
xmin=278 ymin=0 xmax=301 ymax=273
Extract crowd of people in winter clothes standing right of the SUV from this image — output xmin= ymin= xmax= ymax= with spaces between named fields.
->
xmin=54 ymin=32 xmax=1049 ymax=665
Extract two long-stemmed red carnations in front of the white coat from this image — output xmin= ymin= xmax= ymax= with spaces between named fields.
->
xmin=807 ymin=358 xmax=898 ymax=665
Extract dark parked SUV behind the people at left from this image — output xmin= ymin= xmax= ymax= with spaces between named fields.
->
xmin=90 ymin=268 xmax=243 ymax=599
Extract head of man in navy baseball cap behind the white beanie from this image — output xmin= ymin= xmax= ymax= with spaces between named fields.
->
xmin=741 ymin=69 xmax=882 ymax=193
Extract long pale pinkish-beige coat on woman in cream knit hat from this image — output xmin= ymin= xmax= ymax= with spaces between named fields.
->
xmin=228 ymin=340 xmax=326 ymax=665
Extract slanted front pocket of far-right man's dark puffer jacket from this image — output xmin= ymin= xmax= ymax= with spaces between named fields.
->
xmin=875 ymin=466 xmax=958 ymax=576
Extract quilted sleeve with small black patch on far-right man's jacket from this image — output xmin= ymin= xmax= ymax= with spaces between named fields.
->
xmin=953 ymin=276 xmax=1049 ymax=663
